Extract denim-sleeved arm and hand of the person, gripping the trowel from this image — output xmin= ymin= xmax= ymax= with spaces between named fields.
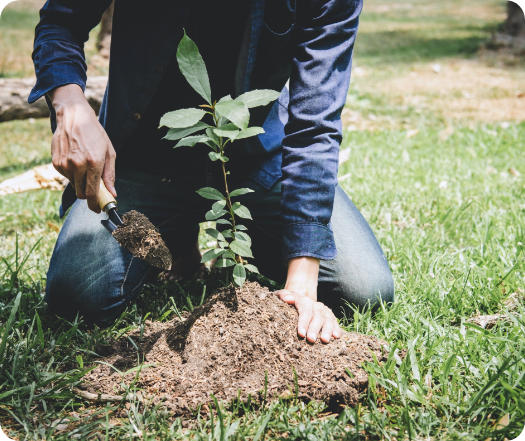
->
xmin=28 ymin=0 xmax=116 ymax=212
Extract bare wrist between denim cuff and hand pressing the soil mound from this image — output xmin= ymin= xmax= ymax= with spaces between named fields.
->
xmin=284 ymin=257 xmax=319 ymax=300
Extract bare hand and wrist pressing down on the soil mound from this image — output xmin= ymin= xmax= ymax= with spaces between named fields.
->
xmin=276 ymin=257 xmax=343 ymax=343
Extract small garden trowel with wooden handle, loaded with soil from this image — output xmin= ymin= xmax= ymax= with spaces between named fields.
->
xmin=98 ymin=180 xmax=173 ymax=270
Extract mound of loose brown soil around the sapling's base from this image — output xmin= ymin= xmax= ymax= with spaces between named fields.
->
xmin=82 ymin=283 xmax=387 ymax=416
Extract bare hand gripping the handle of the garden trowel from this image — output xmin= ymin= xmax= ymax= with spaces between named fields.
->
xmin=49 ymin=84 xmax=117 ymax=213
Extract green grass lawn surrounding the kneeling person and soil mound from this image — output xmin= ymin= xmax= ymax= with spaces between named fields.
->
xmin=0 ymin=0 xmax=525 ymax=441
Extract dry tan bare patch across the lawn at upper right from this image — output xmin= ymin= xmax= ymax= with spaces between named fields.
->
xmin=342 ymin=53 xmax=525 ymax=130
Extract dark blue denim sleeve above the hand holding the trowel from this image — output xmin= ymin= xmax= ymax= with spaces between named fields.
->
xmin=28 ymin=0 xmax=111 ymax=103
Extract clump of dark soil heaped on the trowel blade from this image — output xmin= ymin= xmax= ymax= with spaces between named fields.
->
xmin=112 ymin=210 xmax=173 ymax=270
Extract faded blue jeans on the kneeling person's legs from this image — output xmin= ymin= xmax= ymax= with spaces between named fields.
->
xmin=46 ymin=170 xmax=394 ymax=325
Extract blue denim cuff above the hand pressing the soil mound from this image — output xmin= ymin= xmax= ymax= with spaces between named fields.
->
xmin=283 ymin=222 xmax=336 ymax=260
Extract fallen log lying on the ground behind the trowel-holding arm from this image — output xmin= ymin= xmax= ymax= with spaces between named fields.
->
xmin=0 ymin=76 xmax=107 ymax=122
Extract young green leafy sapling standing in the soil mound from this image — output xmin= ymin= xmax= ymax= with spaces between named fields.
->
xmin=160 ymin=32 xmax=279 ymax=286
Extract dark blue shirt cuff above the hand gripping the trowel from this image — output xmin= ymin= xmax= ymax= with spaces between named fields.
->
xmin=27 ymin=63 xmax=86 ymax=104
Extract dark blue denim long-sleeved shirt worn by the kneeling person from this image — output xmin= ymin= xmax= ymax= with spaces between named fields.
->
xmin=29 ymin=0 xmax=362 ymax=259
